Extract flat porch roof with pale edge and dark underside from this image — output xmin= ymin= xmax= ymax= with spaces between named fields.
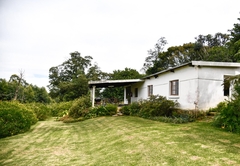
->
xmin=88 ymin=79 xmax=144 ymax=88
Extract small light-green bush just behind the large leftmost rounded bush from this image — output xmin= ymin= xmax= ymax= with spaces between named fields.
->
xmin=26 ymin=103 xmax=51 ymax=121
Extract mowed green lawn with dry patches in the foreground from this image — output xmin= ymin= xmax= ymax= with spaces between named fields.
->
xmin=0 ymin=116 xmax=240 ymax=166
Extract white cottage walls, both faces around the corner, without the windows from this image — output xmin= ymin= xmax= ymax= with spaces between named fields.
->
xmin=131 ymin=66 xmax=240 ymax=110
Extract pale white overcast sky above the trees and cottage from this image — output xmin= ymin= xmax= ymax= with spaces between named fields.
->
xmin=0 ymin=0 xmax=240 ymax=87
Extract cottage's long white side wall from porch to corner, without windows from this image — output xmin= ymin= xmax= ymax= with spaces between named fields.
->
xmin=132 ymin=66 xmax=198 ymax=109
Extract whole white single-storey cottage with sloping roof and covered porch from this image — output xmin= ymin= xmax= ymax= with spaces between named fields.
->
xmin=89 ymin=61 xmax=240 ymax=110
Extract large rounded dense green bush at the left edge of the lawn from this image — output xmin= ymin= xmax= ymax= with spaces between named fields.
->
xmin=0 ymin=102 xmax=37 ymax=138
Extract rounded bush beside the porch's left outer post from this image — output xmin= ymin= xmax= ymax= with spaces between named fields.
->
xmin=69 ymin=96 xmax=91 ymax=118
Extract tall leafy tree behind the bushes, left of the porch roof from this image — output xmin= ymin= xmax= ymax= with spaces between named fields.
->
xmin=48 ymin=51 xmax=93 ymax=101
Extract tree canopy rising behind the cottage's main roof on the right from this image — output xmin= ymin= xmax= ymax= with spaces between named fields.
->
xmin=143 ymin=18 xmax=240 ymax=75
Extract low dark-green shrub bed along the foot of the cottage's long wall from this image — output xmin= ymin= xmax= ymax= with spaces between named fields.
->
xmin=120 ymin=96 xmax=204 ymax=123
